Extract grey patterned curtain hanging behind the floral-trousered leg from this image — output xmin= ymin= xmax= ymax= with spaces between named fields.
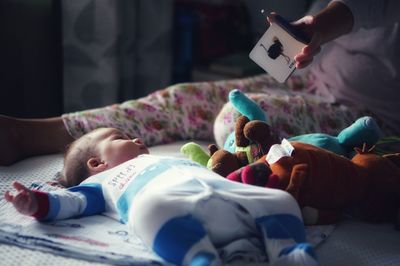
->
xmin=62 ymin=0 xmax=173 ymax=112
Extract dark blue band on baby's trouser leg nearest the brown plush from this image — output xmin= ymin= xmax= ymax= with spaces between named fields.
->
xmin=256 ymin=214 xmax=306 ymax=243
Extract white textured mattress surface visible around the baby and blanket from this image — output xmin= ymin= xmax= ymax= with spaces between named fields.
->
xmin=0 ymin=142 xmax=400 ymax=265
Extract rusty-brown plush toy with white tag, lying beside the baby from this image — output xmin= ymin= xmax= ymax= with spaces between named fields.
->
xmin=227 ymin=142 xmax=400 ymax=224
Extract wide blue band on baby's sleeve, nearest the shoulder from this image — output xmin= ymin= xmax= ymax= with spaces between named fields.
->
xmin=68 ymin=183 xmax=106 ymax=216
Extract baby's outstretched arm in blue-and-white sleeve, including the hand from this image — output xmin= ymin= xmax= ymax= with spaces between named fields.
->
xmin=5 ymin=182 xmax=105 ymax=220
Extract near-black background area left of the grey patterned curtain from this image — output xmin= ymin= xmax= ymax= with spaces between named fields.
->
xmin=0 ymin=0 xmax=62 ymax=117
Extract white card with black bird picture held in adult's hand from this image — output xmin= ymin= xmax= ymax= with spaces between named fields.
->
xmin=249 ymin=15 xmax=310 ymax=83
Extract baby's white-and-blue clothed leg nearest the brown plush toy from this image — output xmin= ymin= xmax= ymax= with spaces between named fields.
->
xmin=235 ymin=188 xmax=317 ymax=266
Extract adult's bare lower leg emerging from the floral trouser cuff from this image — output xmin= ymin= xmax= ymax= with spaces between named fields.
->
xmin=0 ymin=115 xmax=73 ymax=165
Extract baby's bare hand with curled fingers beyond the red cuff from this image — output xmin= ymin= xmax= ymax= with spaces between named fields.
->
xmin=4 ymin=181 xmax=38 ymax=215
